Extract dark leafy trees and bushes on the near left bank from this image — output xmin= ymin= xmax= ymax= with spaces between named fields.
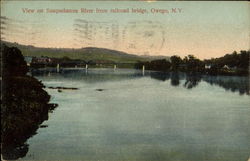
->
xmin=1 ymin=44 xmax=56 ymax=160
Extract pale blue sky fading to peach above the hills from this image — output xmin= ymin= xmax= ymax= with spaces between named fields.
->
xmin=1 ymin=1 xmax=250 ymax=59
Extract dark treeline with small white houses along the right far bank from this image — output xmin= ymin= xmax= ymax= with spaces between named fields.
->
xmin=135 ymin=51 xmax=250 ymax=75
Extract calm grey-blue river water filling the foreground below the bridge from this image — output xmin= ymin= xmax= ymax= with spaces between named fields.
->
xmin=21 ymin=69 xmax=250 ymax=161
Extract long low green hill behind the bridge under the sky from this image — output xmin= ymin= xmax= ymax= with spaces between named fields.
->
xmin=2 ymin=42 xmax=169 ymax=63
